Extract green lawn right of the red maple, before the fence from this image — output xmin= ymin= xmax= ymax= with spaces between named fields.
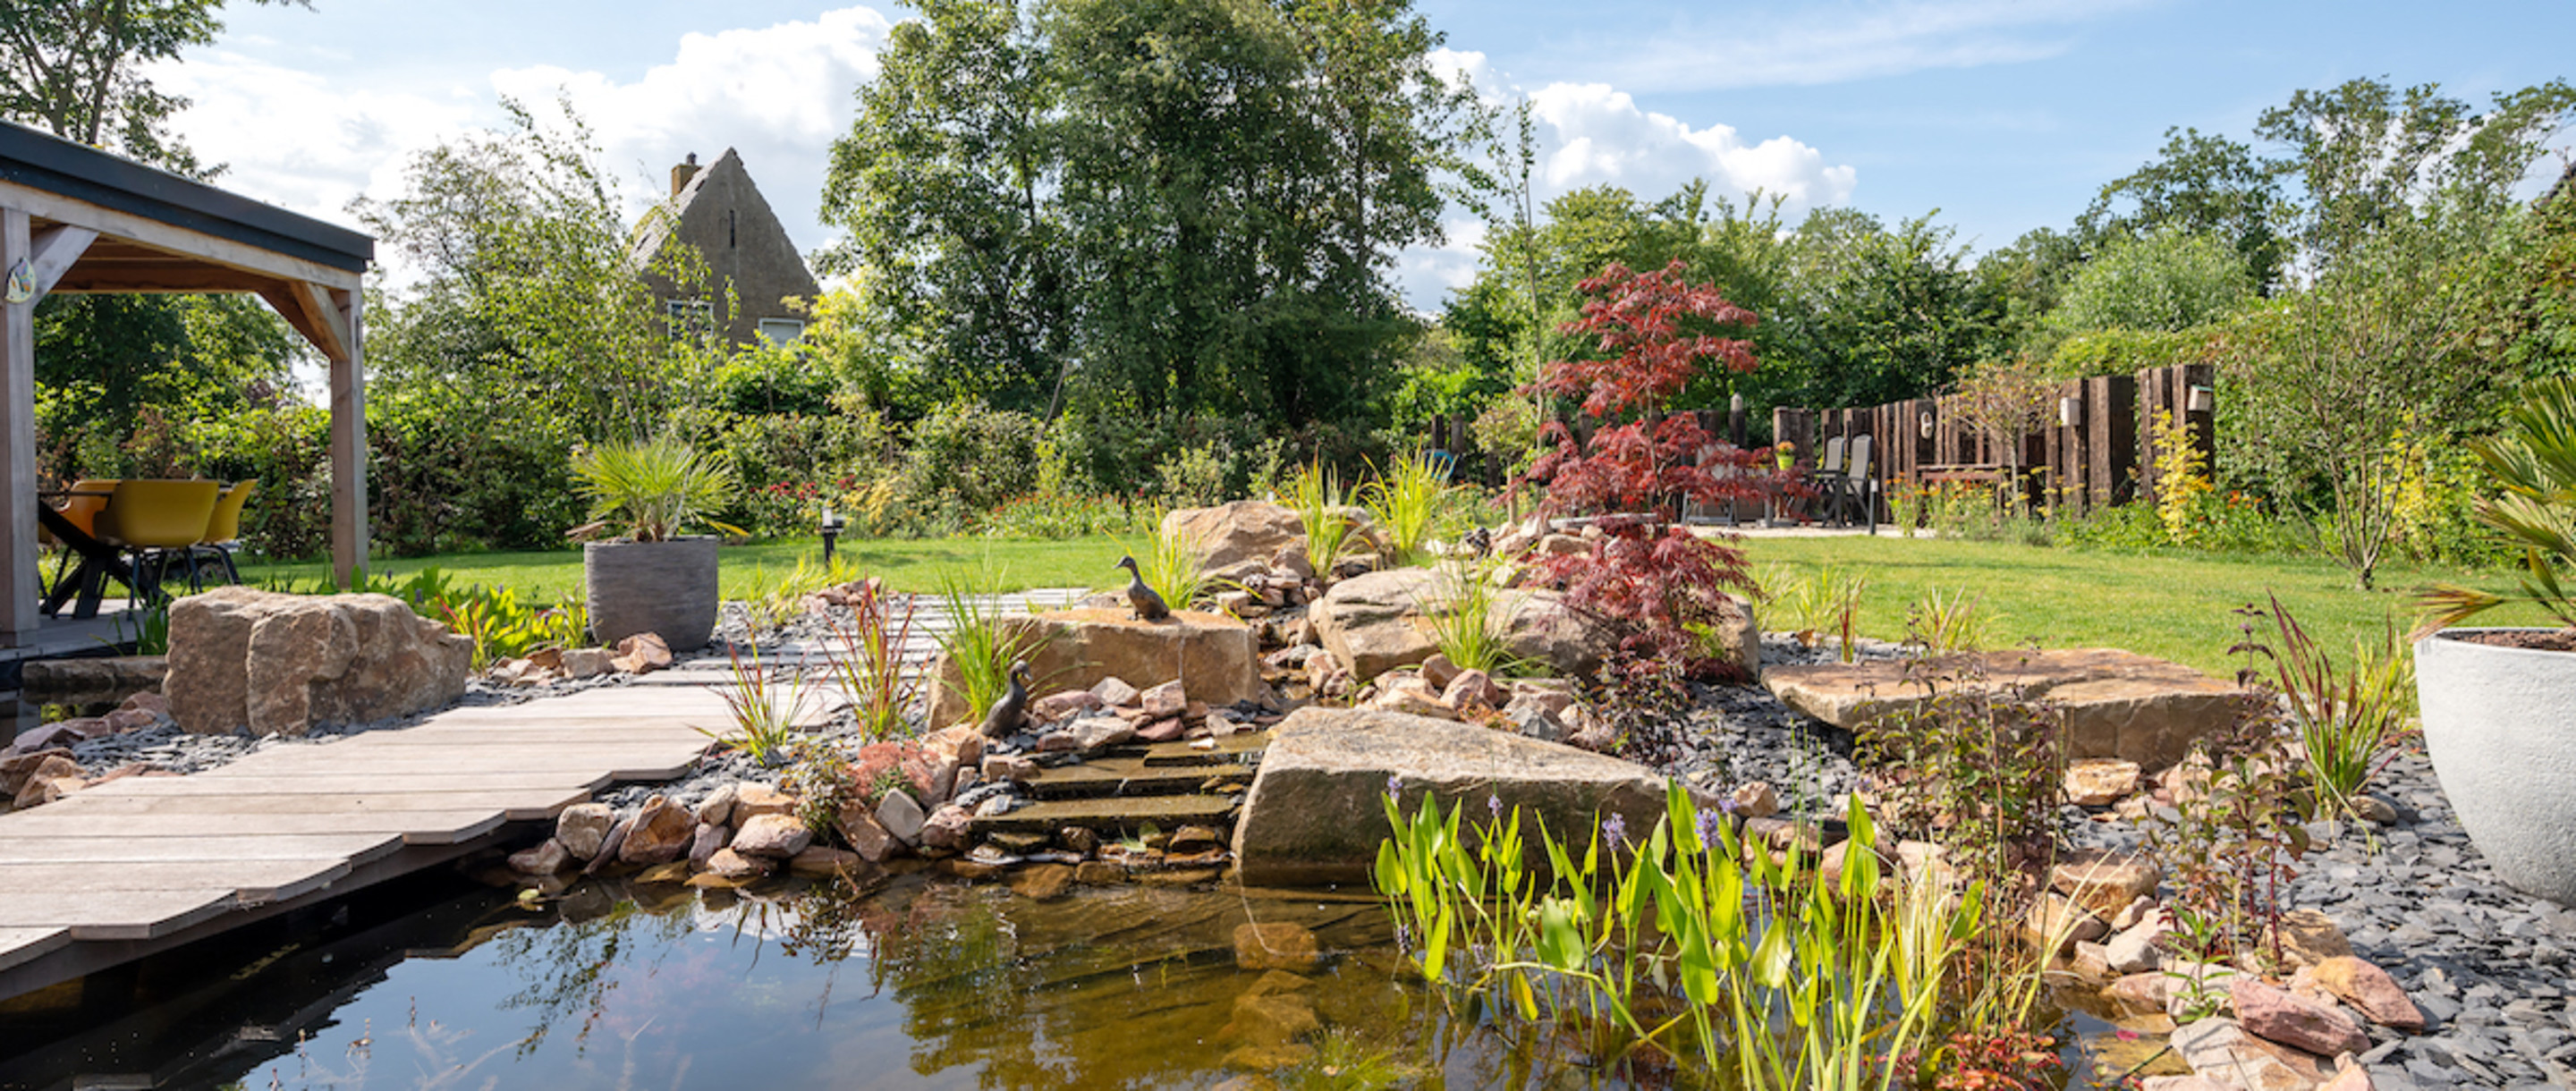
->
xmin=1741 ymin=535 xmax=2550 ymax=677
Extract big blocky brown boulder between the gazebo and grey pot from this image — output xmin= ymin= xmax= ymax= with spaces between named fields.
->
xmin=162 ymin=587 xmax=474 ymax=736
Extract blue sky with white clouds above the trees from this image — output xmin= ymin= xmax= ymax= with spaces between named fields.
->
xmin=152 ymin=0 xmax=2576 ymax=311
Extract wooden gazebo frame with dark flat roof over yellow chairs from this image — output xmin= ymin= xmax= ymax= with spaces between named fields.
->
xmin=0 ymin=121 xmax=376 ymax=648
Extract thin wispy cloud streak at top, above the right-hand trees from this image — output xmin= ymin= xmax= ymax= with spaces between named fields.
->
xmin=1572 ymin=0 xmax=2161 ymax=90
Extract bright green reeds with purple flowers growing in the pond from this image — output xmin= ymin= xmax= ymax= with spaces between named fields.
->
xmin=1376 ymin=785 xmax=1984 ymax=1088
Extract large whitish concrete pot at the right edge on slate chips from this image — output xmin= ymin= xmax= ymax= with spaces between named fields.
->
xmin=2414 ymin=628 xmax=2576 ymax=906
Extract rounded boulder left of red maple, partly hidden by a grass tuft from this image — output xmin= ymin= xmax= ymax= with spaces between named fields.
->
xmin=1309 ymin=569 xmax=1618 ymax=682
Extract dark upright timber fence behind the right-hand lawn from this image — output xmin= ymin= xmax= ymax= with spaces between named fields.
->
xmin=1772 ymin=363 xmax=2216 ymax=514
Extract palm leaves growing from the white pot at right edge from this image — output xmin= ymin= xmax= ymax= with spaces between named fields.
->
xmin=2421 ymin=376 xmax=2576 ymax=633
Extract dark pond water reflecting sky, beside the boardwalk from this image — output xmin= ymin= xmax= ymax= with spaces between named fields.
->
xmin=0 ymin=859 xmax=1731 ymax=1088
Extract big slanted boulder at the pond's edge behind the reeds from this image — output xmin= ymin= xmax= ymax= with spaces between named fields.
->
xmin=1234 ymin=707 xmax=1664 ymax=885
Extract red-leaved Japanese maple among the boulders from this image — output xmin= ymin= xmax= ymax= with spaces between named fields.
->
xmin=1528 ymin=262 xmax=1765 ymax=677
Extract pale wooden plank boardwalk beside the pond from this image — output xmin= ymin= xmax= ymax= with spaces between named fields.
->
xmin=0 ymin=592 xmax=1080 ymax=998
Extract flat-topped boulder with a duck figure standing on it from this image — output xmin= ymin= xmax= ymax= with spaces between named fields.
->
xmin=928 ymin=607 xmax=1262 ymax=725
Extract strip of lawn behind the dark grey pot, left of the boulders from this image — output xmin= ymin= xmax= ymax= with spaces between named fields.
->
xmin=242 ymin=535 xmax=1151 ymax=605
